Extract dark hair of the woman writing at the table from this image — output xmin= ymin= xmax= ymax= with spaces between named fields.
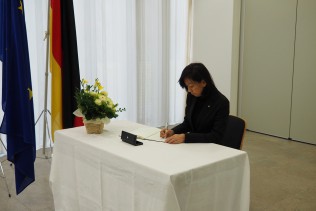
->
xmin=179 ymin=63 xmax=216 ymax=91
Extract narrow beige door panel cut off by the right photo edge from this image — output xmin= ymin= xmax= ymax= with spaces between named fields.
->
xmin=290 ymin=0 xmax=316 ymax=144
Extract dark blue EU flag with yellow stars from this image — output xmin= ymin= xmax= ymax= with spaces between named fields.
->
xmin=0 ymin=0 xmax=36 ymax=194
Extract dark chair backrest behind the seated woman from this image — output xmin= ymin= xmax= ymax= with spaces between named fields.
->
xmin=220 ymin=115 xmax=246 ymax=149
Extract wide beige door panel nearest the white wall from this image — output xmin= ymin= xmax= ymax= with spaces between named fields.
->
xmin=240 ymin=0 xmax=297 ymax=138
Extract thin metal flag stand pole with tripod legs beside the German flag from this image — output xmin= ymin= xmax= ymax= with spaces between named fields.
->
xmin=35 ymin=0 xmax=51 ymax=158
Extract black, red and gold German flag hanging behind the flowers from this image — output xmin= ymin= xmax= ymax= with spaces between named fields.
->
xmin=50 ymin=0 xmax=83 ymax=140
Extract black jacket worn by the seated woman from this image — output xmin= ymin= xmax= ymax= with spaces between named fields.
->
xmin=173 ymin=86 xmax=229 ymax=143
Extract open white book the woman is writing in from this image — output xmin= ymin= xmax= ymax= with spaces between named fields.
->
xmin=130 ymin=126 xmax=165 ymax=142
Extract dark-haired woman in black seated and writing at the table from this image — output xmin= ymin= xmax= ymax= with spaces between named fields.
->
xmin=160 ymin=63 xmax=229 ymax=144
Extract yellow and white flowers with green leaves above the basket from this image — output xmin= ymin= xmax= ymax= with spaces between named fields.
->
xmin=74 ymin=79 xmax=125 ymax=124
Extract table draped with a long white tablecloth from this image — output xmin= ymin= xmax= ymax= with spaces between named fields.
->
xmin=50 ymin=120 xmax=250 ymax=211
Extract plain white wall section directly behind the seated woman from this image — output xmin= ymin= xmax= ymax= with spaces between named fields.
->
xmin=190 ymin=0 xmax=241 ymax=115
